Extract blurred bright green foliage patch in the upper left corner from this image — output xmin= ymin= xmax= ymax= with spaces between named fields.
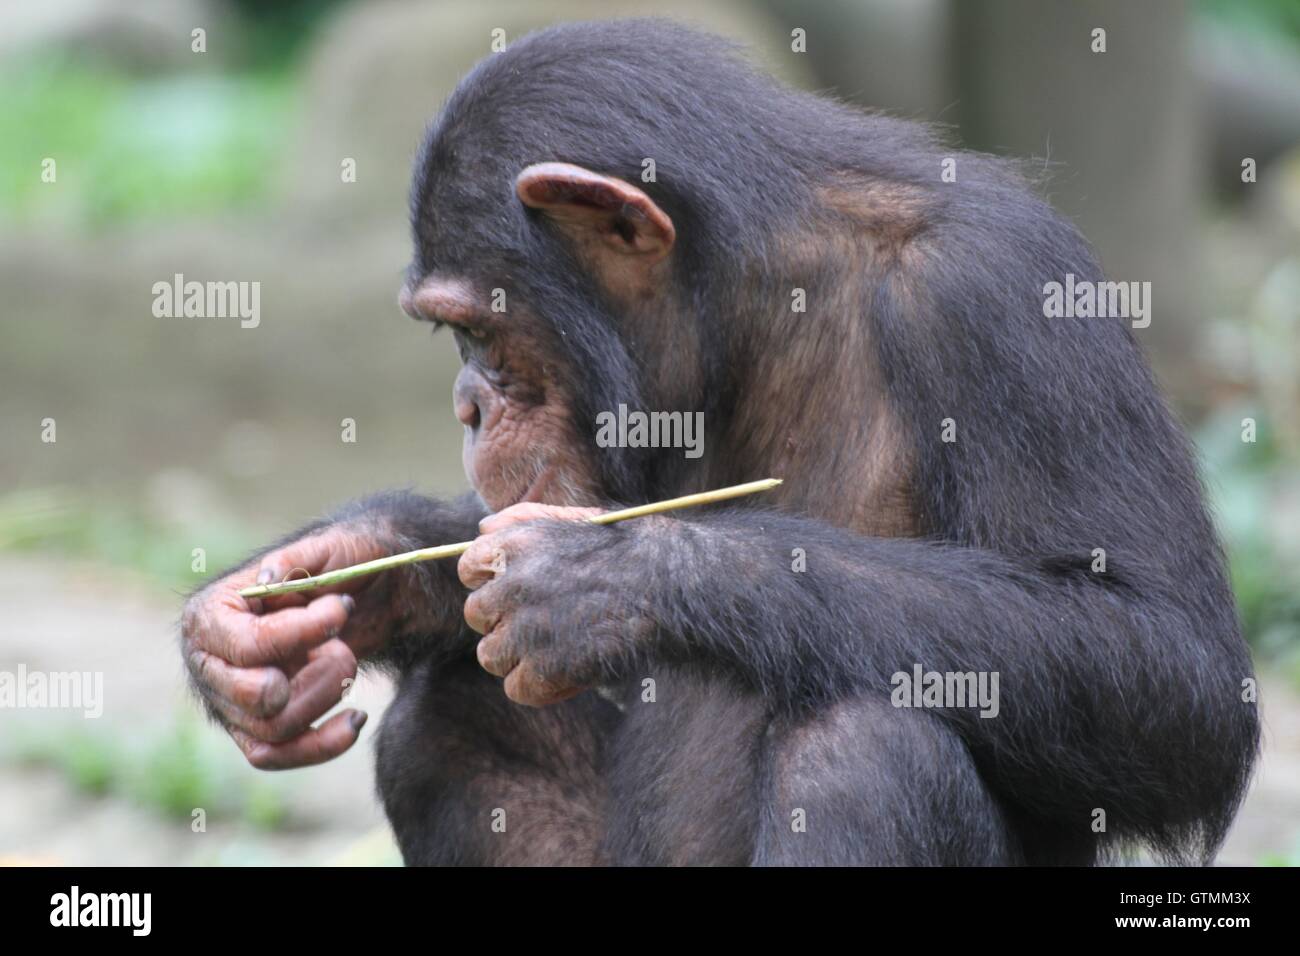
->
xmin=0 ymin=57 xmax=294 ymax=226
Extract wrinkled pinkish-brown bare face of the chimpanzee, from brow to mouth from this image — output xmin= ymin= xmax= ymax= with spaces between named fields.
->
xmin=399 ymin=276 xmax=602 ymax=511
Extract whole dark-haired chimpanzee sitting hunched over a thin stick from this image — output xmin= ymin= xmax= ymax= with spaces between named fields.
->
xmin=183 ymin=21 xmax=1258 ymax=864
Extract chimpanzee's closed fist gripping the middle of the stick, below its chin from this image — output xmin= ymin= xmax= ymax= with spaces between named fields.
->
xmin=459 ymin=503 xmax=660 ymax=706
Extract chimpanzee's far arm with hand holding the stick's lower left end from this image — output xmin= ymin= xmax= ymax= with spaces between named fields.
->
xmin=181 ymin=493 xmax=482 ymax=770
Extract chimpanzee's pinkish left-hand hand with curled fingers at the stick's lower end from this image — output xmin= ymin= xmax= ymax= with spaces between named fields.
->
xmin=181 ymin=523 xmax=391 ymax=770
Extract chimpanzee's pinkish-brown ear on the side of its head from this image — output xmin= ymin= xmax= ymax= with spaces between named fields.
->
xmin=515 ymin=163 xmax=677 ymax=259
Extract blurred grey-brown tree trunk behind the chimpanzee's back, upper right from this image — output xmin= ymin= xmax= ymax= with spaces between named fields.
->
xmin=949 ymin=0 xmax=1204 ymax=405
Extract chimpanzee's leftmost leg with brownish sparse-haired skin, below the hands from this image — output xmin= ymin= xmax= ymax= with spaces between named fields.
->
xmin=376 ymin=661 xmax=619 ymax=865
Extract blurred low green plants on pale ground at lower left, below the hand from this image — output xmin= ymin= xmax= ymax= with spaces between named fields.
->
xmin=5 ymin=711 xmax=289 ymax=830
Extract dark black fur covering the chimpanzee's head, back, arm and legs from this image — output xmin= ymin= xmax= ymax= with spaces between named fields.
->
xmin=351 ymin=21 xmax=1258 ymax=864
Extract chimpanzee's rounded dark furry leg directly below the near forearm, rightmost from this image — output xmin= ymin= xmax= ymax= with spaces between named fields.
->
xmin=753 ymin=697 xmax=1018 ymax=866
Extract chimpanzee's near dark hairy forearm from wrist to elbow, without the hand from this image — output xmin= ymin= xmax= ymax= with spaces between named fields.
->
xmin=636 ymin=511 xmax=1255 ymax=822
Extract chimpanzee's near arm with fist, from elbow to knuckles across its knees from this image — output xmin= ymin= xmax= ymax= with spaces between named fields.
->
xmin=480 ymin=510 xmax=1256 ymax=840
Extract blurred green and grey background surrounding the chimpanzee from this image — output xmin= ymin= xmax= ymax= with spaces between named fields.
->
xmin=0 ymin=0 xmax=1300 ymax=864
